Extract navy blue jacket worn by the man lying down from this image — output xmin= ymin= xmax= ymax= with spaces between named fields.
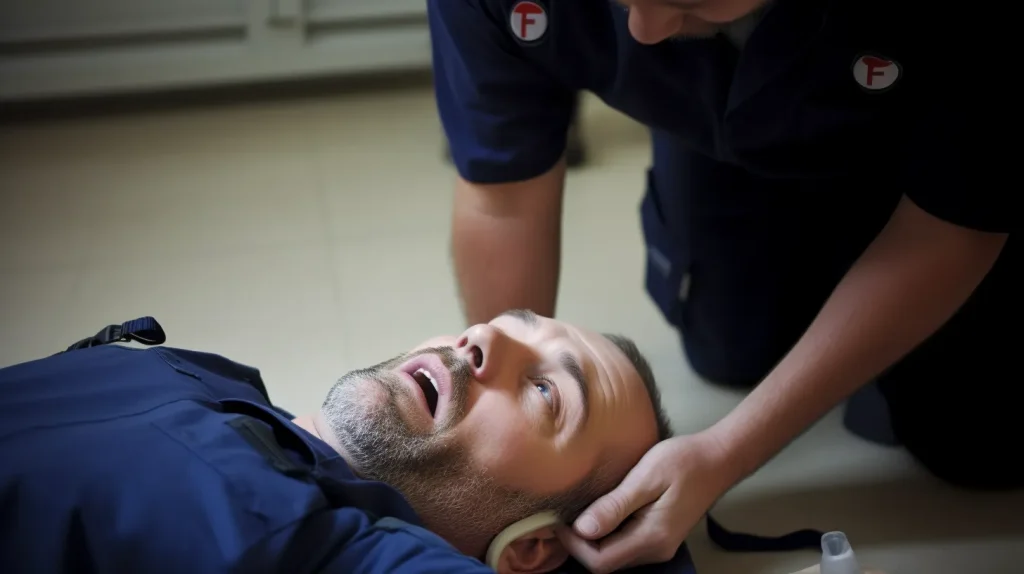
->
xmin=0 ymin=346 xmax=492 ymax=574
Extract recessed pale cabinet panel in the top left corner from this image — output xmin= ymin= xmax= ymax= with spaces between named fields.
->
xmin=0 ymin=0 xmax=249 ymax=44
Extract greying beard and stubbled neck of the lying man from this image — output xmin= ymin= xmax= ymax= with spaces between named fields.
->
xmin=322 ymin=347 xmax=546 ymax=554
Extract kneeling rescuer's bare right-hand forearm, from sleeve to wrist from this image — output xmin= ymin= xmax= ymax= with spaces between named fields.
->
xmin=708 ymin=198 xmax=1006 ymax=482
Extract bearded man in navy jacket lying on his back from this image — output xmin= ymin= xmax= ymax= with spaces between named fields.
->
xmin=0 ymin=312 xmax=670 ymax=574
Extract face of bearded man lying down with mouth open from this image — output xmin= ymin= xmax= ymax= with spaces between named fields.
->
xmin=319 ymin=312 xmax=657 ymax=555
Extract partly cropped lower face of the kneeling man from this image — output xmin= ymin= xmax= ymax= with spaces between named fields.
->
xmin=617 ymin=0 xmax=768 ymax=44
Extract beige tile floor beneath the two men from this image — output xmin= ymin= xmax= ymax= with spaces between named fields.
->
xmin=0 ymin=82 xmax=1024 ymax=574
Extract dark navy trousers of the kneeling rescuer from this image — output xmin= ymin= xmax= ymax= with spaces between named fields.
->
xmin=641 ymin=130 xmax=1024 ymax=488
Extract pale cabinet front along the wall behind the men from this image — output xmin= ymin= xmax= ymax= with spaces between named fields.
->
xmin=0 ymin=0 xmax=430 ymax=101
